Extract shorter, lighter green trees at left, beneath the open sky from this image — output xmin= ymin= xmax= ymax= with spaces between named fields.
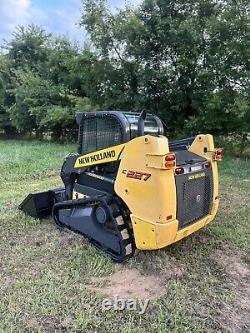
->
xmin=0 ymin=25 xmax=96 ymax=139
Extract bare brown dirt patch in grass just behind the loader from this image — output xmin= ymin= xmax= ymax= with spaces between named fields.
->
xmin=87 ymin=267 xmax=164 ymax=299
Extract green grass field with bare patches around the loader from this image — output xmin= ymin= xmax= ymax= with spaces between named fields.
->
xmin=0 ymin=141 xmax=250 ymax=333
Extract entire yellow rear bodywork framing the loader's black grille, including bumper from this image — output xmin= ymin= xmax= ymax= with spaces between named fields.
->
xmin=115 ymin=135 xmax=219 ymax=250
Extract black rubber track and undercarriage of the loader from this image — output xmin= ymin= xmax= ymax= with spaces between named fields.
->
xmin=21 ymin=191 xmax=135 ymax=262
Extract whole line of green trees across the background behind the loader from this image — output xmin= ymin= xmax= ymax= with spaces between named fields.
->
xmin=0 ymin=0 xmax=250 ymax=144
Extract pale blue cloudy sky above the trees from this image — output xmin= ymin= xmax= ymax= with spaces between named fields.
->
xmin=0 ymin=0 xmax=140 ymax=44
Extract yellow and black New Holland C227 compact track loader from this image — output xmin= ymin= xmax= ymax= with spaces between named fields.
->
xmin=20 ymin=111 xmax=222 ymax=262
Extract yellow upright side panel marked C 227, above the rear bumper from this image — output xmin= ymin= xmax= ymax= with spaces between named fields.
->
xmin=115 ymin=135 xmax=176 ymax=223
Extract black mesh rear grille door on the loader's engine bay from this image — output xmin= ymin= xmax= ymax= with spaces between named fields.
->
xmin=176 ymin=169 xmax=213 ymax=228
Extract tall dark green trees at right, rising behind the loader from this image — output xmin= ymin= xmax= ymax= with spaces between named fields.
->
xmin=81 ymin=0 xmax=250 ymax=133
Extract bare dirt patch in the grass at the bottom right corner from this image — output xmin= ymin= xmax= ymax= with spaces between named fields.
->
xmin=211 ymin=246 xmax=250 ymax=333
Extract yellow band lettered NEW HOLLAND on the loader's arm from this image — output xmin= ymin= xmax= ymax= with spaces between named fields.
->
xmin=74 ymin=144 xmax=125 ymax=169
